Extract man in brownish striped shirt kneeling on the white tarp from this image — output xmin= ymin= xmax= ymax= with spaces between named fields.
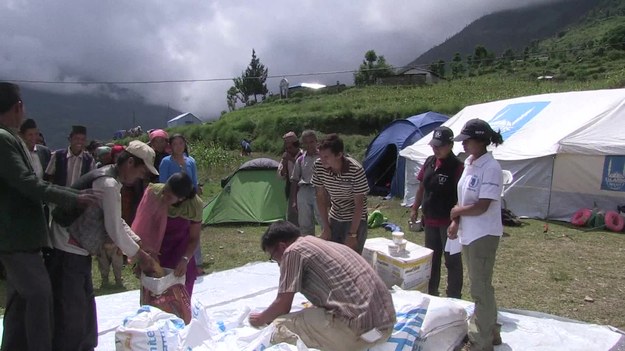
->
xmin=249 ymin=221 xmax=395 ymax=351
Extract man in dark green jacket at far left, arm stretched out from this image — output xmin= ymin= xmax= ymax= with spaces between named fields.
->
xmin=0 ymin=82 xmax=98 ymax=351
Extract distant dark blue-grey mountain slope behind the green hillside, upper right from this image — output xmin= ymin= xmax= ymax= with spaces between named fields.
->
xmin=407 ymin=0 xmax=597 ymax=66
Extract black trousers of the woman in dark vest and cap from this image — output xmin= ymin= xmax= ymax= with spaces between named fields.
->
xmin=425 ymin=225 xmax=462 ymax=299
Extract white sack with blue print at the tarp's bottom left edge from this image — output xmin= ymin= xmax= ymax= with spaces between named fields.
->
xmin=115 ymin=306 xmax=185 ymax=351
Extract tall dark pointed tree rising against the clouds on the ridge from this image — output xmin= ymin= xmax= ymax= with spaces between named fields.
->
xmin=226 ymin=49 xmax=269 ymax=108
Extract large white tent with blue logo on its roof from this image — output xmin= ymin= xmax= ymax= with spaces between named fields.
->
xmin=400 ymin=89 xmax=625 ymax=220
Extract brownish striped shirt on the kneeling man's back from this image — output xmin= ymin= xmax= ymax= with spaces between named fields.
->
xmin=278 ymin=235 xmax=395 ymax=335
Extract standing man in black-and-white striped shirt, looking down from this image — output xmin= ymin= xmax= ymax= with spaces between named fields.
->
xmin=312 ymin=134 xmax=369 ymax=253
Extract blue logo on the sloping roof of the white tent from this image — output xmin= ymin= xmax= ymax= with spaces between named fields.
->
xmin=488 ymin=101 xmax=550 ymax=140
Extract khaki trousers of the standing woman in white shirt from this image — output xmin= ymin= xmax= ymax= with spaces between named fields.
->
xmin=462 ymin=235 xmax=499 ymax=350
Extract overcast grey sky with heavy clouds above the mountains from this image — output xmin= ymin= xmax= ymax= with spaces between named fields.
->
xmin=0 ymin=0 xmax=550 ymax=119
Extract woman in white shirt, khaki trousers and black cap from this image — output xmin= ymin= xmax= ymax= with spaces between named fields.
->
xmin=448 ymin=119 xmax=503 ymax=351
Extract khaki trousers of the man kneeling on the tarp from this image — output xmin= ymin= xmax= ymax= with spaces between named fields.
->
xmin=271 ymin=307 xmax=393 ymax=351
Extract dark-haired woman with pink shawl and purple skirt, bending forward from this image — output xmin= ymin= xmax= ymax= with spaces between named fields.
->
xmin=132 ymin=172 xmax=203 ymax=296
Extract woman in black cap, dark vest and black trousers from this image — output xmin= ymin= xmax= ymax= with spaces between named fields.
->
xmin=410 ymin=127 xmax=463 ymax=299
